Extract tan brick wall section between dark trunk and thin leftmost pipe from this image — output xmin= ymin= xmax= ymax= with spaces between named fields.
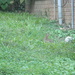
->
xmin=31 ymin=0 xmax=54 ymax=19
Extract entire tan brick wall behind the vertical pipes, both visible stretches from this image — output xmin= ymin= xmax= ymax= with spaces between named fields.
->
xmin=26 ymin=0 xmax=75 ymax=24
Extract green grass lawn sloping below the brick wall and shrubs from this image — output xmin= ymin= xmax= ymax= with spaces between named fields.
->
xmin=0 ymin=12 xmax=75 ymax=75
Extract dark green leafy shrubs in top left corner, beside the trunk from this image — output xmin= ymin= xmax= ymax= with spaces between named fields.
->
xmin=0 ymin=0 xmax=27 ymax=11
